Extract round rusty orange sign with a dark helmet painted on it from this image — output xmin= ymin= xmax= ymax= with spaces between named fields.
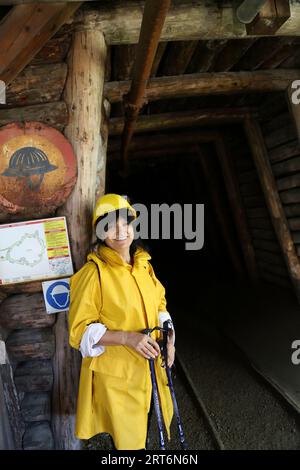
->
xmin=0 ymin=122 xmax=77 ymax=213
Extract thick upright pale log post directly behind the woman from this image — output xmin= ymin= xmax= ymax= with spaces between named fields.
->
xmin=52 ymin=26 xmax=106 ymax=450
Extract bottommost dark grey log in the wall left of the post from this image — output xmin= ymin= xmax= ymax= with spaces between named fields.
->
xmin=23 ymin=421 xmax=54 ymax=450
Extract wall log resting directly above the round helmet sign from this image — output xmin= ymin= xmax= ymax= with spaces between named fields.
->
xmin=0 ymin=101 xmax=68 ymax=131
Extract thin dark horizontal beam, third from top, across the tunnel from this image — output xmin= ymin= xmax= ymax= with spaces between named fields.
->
xmin=109 ymin=108 xmax=257 ymax=136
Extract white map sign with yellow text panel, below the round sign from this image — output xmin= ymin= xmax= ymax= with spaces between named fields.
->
xmin=0 ymin=217 xmax=73 ymax=284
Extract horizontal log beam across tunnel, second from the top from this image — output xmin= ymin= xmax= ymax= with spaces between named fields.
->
xmin=104 ymin=69 xmax=299 ymax=103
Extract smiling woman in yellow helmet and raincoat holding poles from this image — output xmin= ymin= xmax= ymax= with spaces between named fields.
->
xmin=69 ymin=194 xmax=175 ymax=450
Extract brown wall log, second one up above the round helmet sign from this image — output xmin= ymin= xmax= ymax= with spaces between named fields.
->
xmin=6 ymin=63 xmax=67 ymax=106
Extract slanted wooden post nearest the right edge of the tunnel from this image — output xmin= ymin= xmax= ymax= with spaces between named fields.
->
xmin=245 ymin=119 xmax=300 ymax=301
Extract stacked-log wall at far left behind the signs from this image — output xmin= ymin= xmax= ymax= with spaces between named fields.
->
xmin=0 ymin=28 xmax=71 ymax=450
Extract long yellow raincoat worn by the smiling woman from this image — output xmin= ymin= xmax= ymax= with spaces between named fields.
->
xmin=69 ymin=246 xmax=173 ymax=450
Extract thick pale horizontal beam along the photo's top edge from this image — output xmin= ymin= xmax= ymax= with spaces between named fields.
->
xmin=68 ymin=0 xmax=300 ymax=45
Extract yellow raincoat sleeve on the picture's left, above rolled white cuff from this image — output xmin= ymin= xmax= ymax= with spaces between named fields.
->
xmin=69 ymin=262 xmax=102 ymax=349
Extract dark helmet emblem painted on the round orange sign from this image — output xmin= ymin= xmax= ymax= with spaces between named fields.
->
xmin=2 ymin=147 xmax=58 ymax=191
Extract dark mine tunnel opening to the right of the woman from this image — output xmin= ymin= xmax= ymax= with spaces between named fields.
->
xmin=106 ymin=112 xmax=300 ymax=449
